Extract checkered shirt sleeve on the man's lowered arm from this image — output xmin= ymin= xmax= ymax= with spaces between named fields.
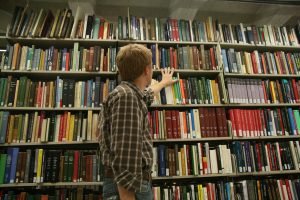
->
xmin=110 ymin=93 xmax=143 ymax=192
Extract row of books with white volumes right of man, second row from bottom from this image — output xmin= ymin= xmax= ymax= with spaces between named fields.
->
xmin=152 ymin=141 xmax=300 ymax=176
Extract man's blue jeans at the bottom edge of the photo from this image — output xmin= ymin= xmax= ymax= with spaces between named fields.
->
xmin=103 ymin=178 xmax=153 ymax=200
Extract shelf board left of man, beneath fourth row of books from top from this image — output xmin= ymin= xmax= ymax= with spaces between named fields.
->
xmin=0 ymin=141 xmax=99 ymax=147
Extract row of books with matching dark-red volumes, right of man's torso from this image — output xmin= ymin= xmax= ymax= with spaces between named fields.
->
xmin=148 ymin=108 xmax=228 ymax=139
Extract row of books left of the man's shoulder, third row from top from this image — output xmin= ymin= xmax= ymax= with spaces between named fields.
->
xmin=0 ymin=76 xmax=116 ymax=108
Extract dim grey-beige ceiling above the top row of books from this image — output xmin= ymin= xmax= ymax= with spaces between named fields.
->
xmin=0 ymin=0 xmax=300 ymax=35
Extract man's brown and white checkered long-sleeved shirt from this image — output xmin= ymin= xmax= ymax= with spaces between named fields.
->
xmin=99 ymin=81 xmax=153 ymax=192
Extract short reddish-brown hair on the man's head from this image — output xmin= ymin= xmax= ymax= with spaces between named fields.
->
xmin=117 ymin=44 xmax=152 ymax=81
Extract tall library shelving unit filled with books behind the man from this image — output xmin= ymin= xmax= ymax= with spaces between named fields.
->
xmin=0 ymin=1 xmax=300 ymax=199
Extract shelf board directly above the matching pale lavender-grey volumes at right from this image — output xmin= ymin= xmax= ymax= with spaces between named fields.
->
xmin=224 ymin=73 xmax=300 ymax=79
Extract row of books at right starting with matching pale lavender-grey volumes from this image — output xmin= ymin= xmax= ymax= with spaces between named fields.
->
xmin=225 ymin=78 xmax=300 ymax=104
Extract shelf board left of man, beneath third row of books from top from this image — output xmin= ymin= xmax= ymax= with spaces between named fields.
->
xmin=0 ymin=107 xmax=101 ymax=111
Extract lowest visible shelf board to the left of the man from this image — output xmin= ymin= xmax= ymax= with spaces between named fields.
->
xmin=0 ymin=182 xmax=103 ymax=188
